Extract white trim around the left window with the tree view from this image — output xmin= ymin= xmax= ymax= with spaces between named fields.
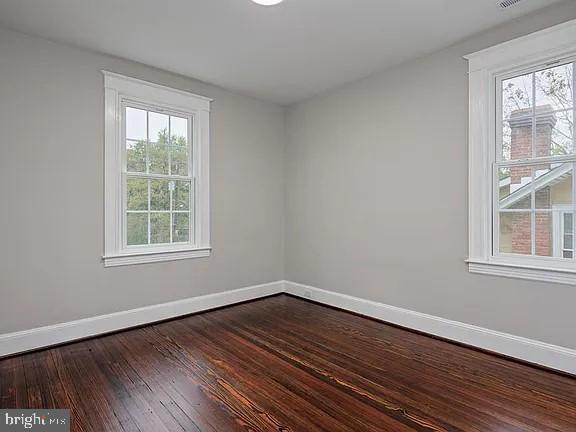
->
xmin=102 ymin=71 xmax=212 ymax=267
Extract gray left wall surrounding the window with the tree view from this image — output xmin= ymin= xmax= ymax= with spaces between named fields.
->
xmin=0 ymin=30 xmax=285 ymax=334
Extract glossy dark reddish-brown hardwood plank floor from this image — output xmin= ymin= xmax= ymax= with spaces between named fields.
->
xmin=0 ymin=296 xmax=576 ymax=432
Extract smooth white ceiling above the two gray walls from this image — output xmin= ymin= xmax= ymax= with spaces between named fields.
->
xmin=0 ymin=0 xmax=556 ymax=104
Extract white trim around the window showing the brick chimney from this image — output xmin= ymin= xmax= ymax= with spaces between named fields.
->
xmin=465 ymin=20 xmax=576 ymax=285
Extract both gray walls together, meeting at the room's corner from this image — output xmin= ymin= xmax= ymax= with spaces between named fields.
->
xmin=0 ymin=1 xmax=576 ymax=358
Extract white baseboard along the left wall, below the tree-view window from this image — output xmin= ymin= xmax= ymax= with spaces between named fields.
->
xmin=0 ymin=281 xmax=283 ymax=357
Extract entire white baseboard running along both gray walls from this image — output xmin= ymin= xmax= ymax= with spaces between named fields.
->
xmin=0 ymin=281 xmax=576 ymax=375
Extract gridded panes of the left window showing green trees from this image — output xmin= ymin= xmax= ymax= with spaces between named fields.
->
xmin=122 ymin=102 xmax=194 ymax=248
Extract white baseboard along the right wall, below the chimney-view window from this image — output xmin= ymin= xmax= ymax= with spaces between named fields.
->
xmin=284 ymin=281 xmax=576 ymax=374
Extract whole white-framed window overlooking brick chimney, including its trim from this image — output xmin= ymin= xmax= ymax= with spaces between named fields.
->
xmin=467 ymin=21 xmax=576 ymax=284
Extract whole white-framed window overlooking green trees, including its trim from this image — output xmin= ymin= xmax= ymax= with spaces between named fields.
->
xmin=104 ymin=72 xmax=210 ymax=266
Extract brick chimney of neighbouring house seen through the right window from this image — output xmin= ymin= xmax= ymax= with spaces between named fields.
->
xmin=508 ymin=105 xmax=556 ymax=256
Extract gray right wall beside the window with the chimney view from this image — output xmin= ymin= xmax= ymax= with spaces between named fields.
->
xmin=285 ymin=2 xmax=576 ymax=348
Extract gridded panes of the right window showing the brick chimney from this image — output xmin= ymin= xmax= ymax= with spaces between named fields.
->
xmin=493 ymin=62 xmax=576 ymax=261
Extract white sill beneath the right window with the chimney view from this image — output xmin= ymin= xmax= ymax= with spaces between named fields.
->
xmin=466 ymin=260 xmax=576 ymax=285
